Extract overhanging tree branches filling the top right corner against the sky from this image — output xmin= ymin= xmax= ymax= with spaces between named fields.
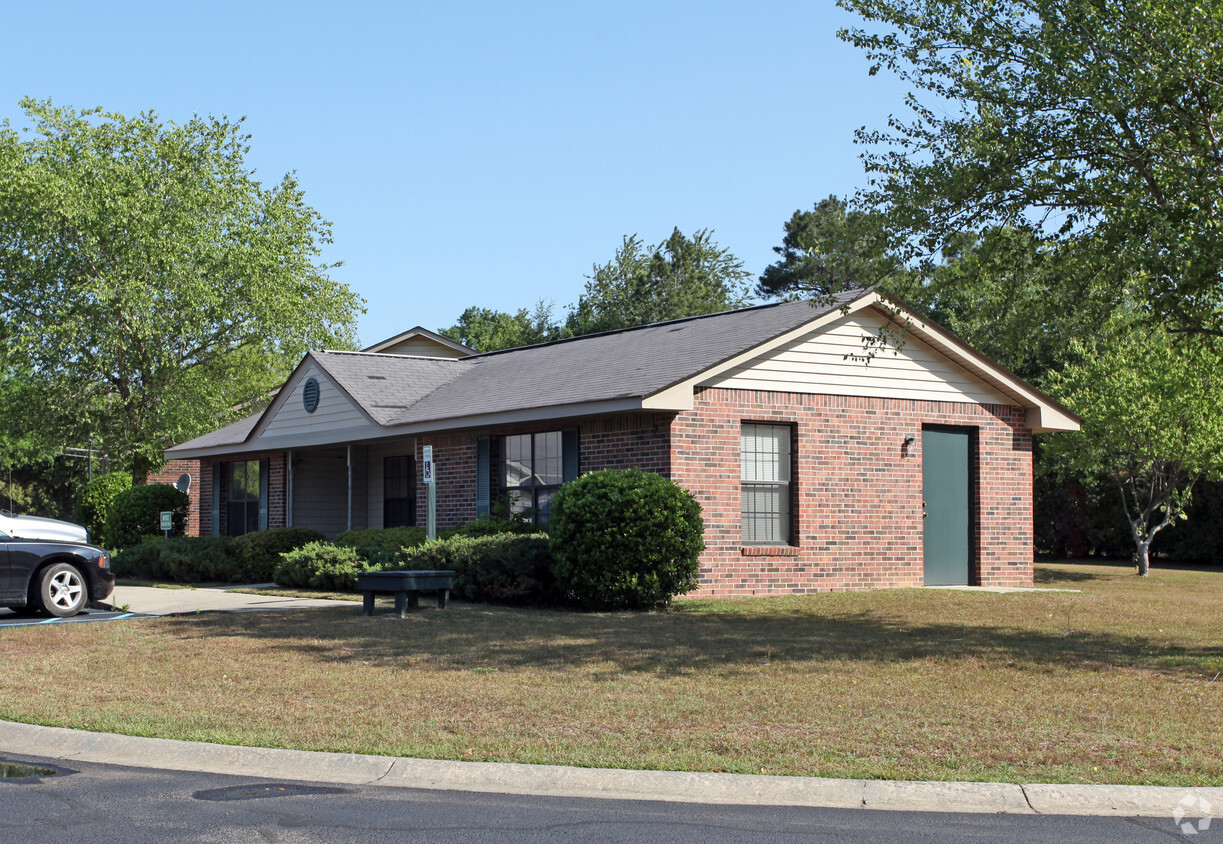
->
xmin=838 ymin=0 xmax=1223 ymax=335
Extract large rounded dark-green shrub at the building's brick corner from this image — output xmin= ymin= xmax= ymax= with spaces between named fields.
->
xmin=548 ymin=468 xmax=704 ymax=609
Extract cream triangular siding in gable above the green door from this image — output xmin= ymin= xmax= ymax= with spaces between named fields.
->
xmin=700 ymin=311 xmax=1011 ymax=404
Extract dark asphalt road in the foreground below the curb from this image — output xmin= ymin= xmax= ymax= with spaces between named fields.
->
xmin=0 ymin=756 xmax=1203 ymax=844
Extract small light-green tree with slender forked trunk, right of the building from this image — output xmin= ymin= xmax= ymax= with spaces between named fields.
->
xmin=1047 ymin=327 xmax=1223 ymax=576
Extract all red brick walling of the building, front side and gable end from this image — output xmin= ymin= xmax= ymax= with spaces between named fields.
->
xmin=172 ymin=388 xmax=1032 ymax=596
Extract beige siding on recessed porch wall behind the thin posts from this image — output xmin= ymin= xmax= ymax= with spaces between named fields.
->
xmin=294 ymin=446 xmax=368 ymax=538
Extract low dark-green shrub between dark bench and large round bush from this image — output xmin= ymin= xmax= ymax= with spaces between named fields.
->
xmin=400 ymin=533 xmax=556 ymax=604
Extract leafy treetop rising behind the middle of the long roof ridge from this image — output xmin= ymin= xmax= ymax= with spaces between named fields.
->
xmin=566 ymin=229 xmax=750 ymax=336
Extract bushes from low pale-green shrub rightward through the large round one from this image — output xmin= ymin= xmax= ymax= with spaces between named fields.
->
xmin=267 ymin=470 xmax=704 ymax=609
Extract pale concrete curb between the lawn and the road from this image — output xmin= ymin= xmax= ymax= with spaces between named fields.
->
xmin=0 ymin=720 xmax=1223 ymax=818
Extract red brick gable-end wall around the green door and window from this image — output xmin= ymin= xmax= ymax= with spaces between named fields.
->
xmin=671 ymin=388 xmax=1032 ymax=596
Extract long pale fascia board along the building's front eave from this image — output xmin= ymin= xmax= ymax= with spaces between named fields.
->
xmin=166 ymin=399 xmax=651 ymax=460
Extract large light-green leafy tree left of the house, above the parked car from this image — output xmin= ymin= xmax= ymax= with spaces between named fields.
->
xmin=0 ymin=99 xmax=360 ymax=481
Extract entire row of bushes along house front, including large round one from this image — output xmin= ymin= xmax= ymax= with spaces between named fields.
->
xmin=115 ymin=470 xmax=704 ymax=609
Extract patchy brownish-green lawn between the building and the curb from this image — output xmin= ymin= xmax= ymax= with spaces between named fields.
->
xmin=0 ymin=564 xmax=1223 ymax=785
